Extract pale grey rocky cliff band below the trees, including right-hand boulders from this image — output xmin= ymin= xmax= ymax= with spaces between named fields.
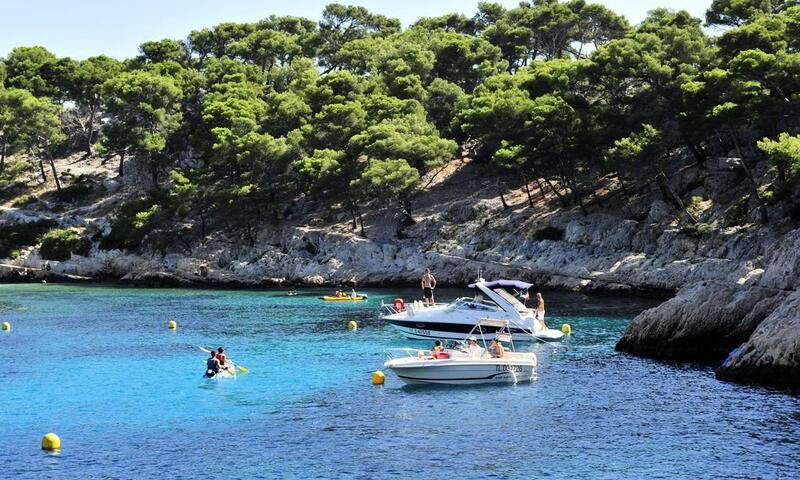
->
xmin=0 ymin=159 xmax=800 ymax=384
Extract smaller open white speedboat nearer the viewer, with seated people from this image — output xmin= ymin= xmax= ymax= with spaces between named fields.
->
xmin=384 ymin=318 xmax=536 ymax=385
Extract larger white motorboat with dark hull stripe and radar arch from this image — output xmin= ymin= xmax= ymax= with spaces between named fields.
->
xmin=381 ymin=279 xmax=564 ymax=342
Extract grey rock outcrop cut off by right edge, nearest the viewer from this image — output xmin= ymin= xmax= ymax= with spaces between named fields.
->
xmin=717 ymin=291 xmax=800 ymax=388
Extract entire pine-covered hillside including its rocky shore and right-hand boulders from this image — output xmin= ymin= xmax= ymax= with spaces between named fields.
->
xmin=0 ymin=0 xmax=800 ymax=386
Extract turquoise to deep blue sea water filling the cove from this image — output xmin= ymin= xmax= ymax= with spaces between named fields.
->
xmin=0 ymin=285 xmax=800 ymax=479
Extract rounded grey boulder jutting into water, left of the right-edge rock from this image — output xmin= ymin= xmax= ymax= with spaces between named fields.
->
xmin=616 ymin=282 xmax=800 ymax=361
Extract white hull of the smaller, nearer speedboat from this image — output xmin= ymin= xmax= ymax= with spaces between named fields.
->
xmin=384 ymin=357 xmax=536 ymax=385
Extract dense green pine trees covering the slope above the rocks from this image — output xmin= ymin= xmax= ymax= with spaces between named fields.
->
xmin=0 ymin=0 xmax=800 ymax=257
